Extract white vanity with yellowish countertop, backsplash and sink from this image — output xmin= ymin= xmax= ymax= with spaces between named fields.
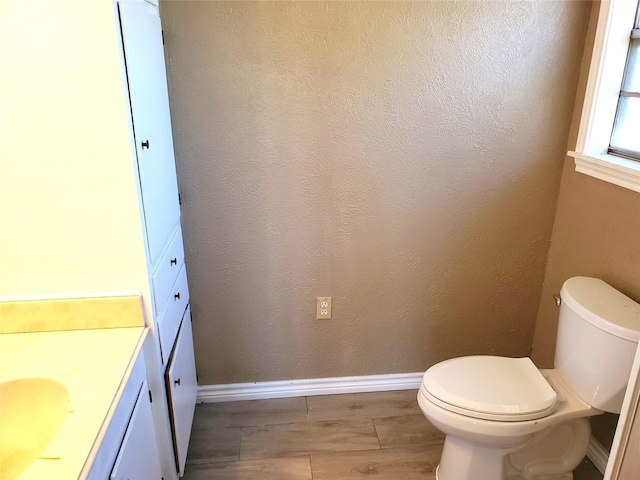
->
xmin=0 ymin=296 xmax=155 ymax=480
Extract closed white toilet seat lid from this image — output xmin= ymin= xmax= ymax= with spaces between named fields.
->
xmin=422 ymin=355 xmax=557 ymax=421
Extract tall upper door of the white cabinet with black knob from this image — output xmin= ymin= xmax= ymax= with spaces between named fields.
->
xmin=118 ymin=1 xmax=180 ymax=264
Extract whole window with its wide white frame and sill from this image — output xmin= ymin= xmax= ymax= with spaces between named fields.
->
xmin=569 ymin=0 xmax=640 ymax=193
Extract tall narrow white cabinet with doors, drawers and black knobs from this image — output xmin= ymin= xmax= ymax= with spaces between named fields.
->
xmin=113 ymin=1 xmax=197 ymax=478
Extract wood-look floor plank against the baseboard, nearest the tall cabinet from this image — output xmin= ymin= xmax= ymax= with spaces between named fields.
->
xmin=193 ymin=397 xmax=307 ymax=429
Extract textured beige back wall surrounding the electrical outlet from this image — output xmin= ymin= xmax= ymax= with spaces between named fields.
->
xmin=161 ymin=1 xmax=590 ymax=384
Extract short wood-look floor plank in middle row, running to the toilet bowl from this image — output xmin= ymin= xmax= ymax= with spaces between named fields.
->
xmin=373 ymin=415 xmax=445 ymax=448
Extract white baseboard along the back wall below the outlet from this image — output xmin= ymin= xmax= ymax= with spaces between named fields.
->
xmin=197 ymin=372 xmax=424 ymax=403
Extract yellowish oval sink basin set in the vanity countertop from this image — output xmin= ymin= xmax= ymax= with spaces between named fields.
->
xmin=0 ymin=378 xmax=69 ymax=480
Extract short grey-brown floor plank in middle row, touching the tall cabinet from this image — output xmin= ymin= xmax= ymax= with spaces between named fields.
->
xmin=187 ymin=428 xmax=240 ymax=464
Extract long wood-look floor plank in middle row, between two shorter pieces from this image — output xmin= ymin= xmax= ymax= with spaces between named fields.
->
xmin=240 ymin=420 xmax=380 ymax=460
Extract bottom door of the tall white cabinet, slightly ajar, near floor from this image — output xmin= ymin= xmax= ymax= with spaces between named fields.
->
xmin=165 ymin=308 xmax=198 ymax=475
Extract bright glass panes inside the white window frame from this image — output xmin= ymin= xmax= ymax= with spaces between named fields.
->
xmin=609 ymin=4 xmax=640 ymax=160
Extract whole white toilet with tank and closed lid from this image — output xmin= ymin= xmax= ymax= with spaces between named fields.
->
xmin=418 ymin=277 xmax=640 ymax=480
